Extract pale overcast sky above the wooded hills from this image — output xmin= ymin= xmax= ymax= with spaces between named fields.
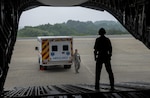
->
xmin=19 ymin=7 xmax=117 ymax=27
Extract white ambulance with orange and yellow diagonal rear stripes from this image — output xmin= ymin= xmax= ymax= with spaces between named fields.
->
xmin=36 ymin=36 xmax=73 ymax=69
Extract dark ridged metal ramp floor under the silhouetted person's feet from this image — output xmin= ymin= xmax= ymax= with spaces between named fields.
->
xmin=2 ymin=82 xmax=150 ymax=98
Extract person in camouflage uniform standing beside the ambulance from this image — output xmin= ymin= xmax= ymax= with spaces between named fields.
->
xmin=73 ymin=49 xmax=81 ymax=73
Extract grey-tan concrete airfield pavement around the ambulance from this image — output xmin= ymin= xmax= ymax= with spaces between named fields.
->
xmin=4 ymin=36 xmax=150 ymax=90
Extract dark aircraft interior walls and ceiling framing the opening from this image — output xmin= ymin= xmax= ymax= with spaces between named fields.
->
xmin=0 ymin=0 xmax=150 ymax=93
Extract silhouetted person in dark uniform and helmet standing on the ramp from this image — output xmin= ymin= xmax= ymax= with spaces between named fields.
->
xmin=94 ymin=28 xmax=114 ymax=90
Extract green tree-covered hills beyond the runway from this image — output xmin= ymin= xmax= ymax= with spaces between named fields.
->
xmin=18 ymin=20 xmax=129 ymax=37
